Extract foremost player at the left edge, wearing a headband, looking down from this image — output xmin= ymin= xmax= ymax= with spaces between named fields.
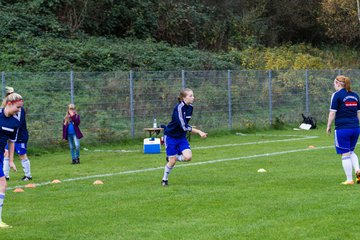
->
xmin=0 ymin=93 xmax=23 ymax=228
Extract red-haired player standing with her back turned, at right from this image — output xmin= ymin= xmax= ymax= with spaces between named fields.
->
xmin=326 ymin=75 xmax=360 ymax=185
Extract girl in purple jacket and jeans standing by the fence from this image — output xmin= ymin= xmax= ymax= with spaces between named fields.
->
xmin=63 ymin=104 xmax=83 ymax=164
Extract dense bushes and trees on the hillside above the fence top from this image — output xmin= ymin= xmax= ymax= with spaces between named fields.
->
xmin=0 ymin=0 xmax=360 ymax=72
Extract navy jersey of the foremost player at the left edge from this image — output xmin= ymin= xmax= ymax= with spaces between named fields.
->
xmin=0 ymin=108 xmax=20 ymax=156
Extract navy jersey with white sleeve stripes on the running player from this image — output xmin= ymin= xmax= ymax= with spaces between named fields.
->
xmin=164 ymin=101 xmax=193 ymax=138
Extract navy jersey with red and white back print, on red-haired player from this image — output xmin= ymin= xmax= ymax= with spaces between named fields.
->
xmin=330 ymin=88 xmax=360 ymax=129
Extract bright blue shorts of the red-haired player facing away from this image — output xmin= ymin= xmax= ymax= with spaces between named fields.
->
xmin=334 ymin=128 xmax=359 ymax=154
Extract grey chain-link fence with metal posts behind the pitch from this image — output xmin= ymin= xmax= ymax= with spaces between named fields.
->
xmin=2 ymin=70 xmax=360 ymax=145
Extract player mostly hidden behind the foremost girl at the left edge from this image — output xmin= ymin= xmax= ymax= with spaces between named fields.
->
xmin=3 ymin=87 xmax=32 ymax=181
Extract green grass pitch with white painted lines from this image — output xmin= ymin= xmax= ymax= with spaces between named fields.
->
xmin=0 ymin=129 xmax=360 ymax=240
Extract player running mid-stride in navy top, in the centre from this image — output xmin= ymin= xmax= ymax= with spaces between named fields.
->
xmin=161 ymin=88 xmax=207 ymax=186
